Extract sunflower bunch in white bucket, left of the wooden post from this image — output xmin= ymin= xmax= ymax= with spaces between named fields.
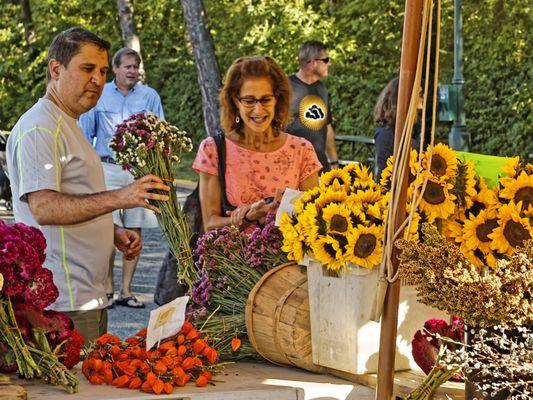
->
xmin=280 ymin=163 xmax=387 ymax=272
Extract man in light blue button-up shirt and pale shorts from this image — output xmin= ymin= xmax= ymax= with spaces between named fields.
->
xmin=79 ymin=48 xmax=164 ymax=308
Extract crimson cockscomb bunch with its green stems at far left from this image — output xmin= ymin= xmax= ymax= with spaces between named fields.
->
xmin=0 ymin=221 xmax=79 ymax=393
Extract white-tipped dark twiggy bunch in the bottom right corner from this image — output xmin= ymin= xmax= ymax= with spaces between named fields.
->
xmin=439 ymin=325 xmax=533 ymax=400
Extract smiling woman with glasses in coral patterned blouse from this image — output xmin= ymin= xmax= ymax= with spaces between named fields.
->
xmin=193 ymin=56 xmax=322 ymax=231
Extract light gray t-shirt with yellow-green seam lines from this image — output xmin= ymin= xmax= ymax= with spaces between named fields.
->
xmin=7 ymin=99 xmax=114 ymax=311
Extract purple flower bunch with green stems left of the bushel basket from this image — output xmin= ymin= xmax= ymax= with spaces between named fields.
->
xmin=188 ymin=215 xmax=288 ymax=359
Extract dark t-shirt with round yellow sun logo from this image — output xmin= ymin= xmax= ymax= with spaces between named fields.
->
xmin=285 ymin=75 xmax=331 ymax=170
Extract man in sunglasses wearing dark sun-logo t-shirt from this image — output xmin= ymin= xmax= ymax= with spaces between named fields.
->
xmin=286 ymin=41 xmax=339 ymax=172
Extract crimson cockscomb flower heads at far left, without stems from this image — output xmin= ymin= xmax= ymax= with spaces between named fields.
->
xmin=0 ymin=220 xmax=83 ymax=371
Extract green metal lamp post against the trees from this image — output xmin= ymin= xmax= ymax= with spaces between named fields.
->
xmin=448 ymin=0 xmax=470 ymax=151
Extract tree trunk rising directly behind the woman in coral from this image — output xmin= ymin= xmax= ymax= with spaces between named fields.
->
xmin=181 ymin=0 xmax=220 ymax=136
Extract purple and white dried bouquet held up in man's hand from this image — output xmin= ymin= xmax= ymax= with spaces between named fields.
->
xmin=109 ymin=113 xmax=196 ymax=287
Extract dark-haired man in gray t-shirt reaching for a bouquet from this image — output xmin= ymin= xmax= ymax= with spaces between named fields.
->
xmin=7 ymin=27 xmax=170 ymax=345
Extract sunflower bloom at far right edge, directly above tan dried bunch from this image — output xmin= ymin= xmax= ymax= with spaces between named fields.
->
xmin=488 ymin=201 xmax=533 ymax=255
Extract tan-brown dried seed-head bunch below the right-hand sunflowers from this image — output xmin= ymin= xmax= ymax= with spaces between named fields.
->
xmin=397 ymin=224 xmax=533 ymax=326
